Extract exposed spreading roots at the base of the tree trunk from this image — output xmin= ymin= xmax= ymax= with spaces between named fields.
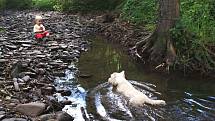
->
xmin=131 ymin=31 xmax=176 ymax=71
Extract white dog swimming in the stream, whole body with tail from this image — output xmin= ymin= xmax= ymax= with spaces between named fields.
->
xmin=108 ymin=71 xmax=166 ymax=106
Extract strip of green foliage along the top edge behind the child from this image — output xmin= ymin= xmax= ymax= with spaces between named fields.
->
xmin=0 ymin=0 xmax=123 ymax=12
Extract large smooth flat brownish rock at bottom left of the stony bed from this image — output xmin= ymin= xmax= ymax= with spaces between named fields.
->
xmin=16 ymin=102 xmax=46 ymax=117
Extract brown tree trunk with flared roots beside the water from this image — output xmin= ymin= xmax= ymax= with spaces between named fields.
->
xmin=133 ymin=0 xmax=179 ymax=68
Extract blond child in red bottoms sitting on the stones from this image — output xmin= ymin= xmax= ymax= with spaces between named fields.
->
xmin=33 ymin=16 xmax=49 ymax=39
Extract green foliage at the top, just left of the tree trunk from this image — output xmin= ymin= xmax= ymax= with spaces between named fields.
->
xmin=121 ymin=0 xmax=158 ymax=30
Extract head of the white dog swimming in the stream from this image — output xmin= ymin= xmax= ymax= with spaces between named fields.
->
xmin=108 ymin=71 xmax=125 ymax=86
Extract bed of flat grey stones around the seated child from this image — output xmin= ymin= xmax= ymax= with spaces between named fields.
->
xmin=0 ymin=11 xmax=94 ymax=121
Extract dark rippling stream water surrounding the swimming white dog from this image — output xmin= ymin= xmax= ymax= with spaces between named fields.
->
xmin=57 ymin=37 xmax=215 ymax=121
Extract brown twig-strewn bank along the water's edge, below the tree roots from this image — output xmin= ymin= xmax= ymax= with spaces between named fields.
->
xmin=91 ymin=13 xmax=215 ymax=79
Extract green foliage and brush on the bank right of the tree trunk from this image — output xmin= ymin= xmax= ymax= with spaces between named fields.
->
xmin=172 ymin=0 xmax=215 ymax=72
